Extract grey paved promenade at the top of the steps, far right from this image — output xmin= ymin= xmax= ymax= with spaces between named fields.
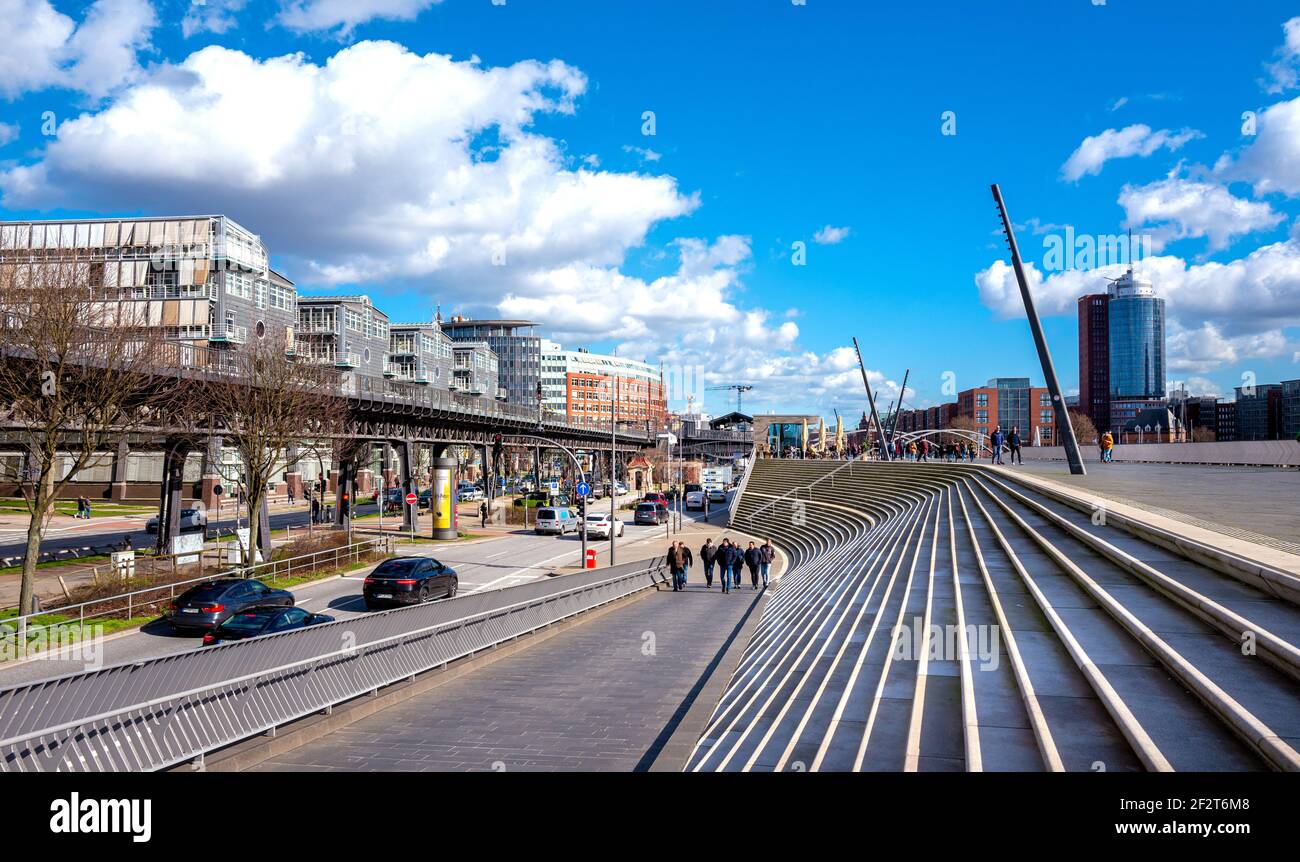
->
xmin=1014 ymin=462 xmax=1300 ymax=554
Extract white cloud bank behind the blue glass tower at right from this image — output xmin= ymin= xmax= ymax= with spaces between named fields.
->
xmin=975 ymin=239 xmax=1300 ymax=372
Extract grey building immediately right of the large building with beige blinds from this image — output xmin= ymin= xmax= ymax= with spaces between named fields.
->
xmin=296 ymin=296 xmax=389 ymax=377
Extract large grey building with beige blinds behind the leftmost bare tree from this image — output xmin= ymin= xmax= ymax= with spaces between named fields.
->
xmin=0 ymin=216 xmax=296 ymax=347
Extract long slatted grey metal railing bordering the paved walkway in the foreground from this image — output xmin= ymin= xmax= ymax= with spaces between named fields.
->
xmin=0 ymin=558 xmax=664 ymax=772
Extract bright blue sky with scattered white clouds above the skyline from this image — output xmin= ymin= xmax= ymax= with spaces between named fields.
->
xmin=0 ymin=0 xmax=1300 ymax=413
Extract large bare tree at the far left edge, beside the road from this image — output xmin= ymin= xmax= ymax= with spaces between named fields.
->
xmin=0 ymin=256 xmax=189 ymax=614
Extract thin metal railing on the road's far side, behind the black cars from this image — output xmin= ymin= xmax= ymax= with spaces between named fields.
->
xmin=0 ymin=537 xmax=393 ymax=650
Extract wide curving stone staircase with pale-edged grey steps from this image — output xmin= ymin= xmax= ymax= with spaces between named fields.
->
xmin=686 ymin=459 xmax=1300 ymax=771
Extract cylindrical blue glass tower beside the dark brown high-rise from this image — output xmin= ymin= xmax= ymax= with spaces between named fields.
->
xmin=1108 ymin=269 xmax=1165 ymax=399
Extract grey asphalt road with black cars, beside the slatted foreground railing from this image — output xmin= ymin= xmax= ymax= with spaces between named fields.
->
xmin=0 ymin=498 xmax=731 ymax=688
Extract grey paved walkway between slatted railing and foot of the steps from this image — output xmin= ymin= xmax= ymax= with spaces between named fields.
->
xmin=248 ymin=579 xmax=762 ymax=772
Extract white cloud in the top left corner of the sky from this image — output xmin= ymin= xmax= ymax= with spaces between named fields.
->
xmin=0 ymin=0 xmax=157 ymax=99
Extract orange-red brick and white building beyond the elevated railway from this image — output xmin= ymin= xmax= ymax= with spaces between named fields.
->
xmin=542 ymin=341 xmax=668 ymax=426
